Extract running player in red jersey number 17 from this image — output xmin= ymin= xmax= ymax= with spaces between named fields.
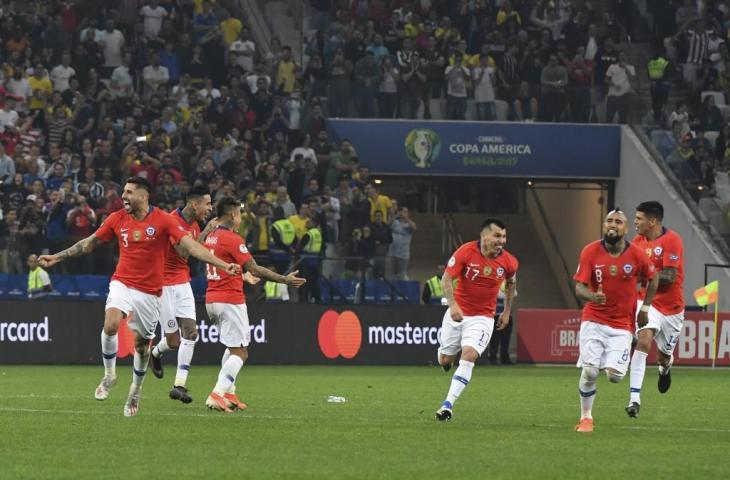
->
xmin=436 ymin=218 xmax=518 ymax=421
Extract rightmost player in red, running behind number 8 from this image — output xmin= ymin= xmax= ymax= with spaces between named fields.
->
xmin=626 ymin=201 xmax=684 ymax=418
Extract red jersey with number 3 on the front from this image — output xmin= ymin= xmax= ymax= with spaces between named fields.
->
xmin=95 ymin=206 xmax=188 ymax=296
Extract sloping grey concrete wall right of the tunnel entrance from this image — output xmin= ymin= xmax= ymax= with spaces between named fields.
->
xmin=616 ymin=127 xmax=730 ymax=305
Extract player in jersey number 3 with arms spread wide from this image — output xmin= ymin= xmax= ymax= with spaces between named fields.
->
xmin=39 ymin=177 xmax=240 ymax=417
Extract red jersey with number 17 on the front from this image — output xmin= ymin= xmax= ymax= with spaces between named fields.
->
xmin=446 ymin=241 xmax=519 ymax=318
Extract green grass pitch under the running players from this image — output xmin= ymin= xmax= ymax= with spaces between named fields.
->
xmin=0 ymin=365 xmax=730 ymax=480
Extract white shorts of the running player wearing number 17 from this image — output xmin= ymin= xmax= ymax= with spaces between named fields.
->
xmin=438 ymin=308 xmax=494 ymax=356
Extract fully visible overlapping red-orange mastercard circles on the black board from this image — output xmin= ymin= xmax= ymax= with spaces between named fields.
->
xmin=317 ymin=310 xmax=362 ymax=359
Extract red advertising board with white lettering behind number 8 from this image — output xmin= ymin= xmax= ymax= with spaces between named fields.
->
xmin=517 ymin=309 xmax=730 ymax=366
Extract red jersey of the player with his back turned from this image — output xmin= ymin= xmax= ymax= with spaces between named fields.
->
xmin=205 ymin=225 xmax=253 ymax=305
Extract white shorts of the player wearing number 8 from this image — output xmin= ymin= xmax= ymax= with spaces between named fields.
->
xmin=577 ymin=321 xmax=632 ymax=376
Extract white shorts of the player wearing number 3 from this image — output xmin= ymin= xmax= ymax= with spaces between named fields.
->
xmin=104 ymin=280 xmax=162 ymax=338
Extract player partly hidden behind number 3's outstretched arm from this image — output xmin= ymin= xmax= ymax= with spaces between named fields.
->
xmin=150 ymin=186 xmax=217 ymax=403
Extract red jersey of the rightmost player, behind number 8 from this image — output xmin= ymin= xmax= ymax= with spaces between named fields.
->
xmin=633 ymin=228 xmax=684 ymax=315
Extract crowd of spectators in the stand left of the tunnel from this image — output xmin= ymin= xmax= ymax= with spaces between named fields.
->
xmin=0 ymin=0 xmax=415 ymax=278
